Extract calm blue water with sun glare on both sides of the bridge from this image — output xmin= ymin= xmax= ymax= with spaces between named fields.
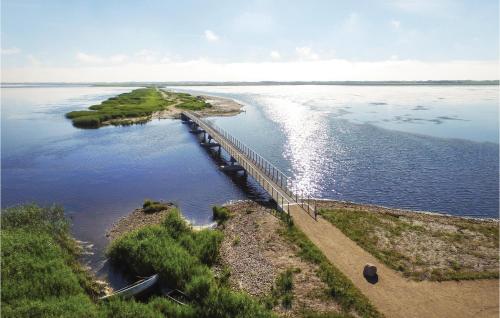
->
xmin=1 ymin=86 xmax=499 ymax=284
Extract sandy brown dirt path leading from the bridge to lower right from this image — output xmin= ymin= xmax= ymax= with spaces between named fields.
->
xmin=290 ymin=206 xmax=499 ymax=318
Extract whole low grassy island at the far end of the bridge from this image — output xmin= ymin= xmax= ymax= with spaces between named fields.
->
xmin=66 ymin=87 xmax=210 ymax=128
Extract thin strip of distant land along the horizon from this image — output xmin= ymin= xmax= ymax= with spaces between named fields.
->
xmin=1 ymin=80 xmax=500 ymax=87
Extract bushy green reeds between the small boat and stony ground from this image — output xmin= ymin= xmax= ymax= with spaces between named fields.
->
xmin=108 ymin=210 xmax=272 ymax=317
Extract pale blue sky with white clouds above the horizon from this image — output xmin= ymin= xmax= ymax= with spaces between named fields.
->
xmin=0 ymin=0 xmax=499 ymax=82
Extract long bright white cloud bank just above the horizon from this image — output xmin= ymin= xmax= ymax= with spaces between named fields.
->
xmin=2 ymin=59 xmax=499 ymax=82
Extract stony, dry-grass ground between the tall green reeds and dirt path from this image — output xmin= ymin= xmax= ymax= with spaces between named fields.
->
xmin=219 ymin=201 xmax=378 ymax=317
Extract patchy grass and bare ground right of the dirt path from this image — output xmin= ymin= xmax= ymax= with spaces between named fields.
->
xmin=320 ymin=209 xmax=499 ymax=281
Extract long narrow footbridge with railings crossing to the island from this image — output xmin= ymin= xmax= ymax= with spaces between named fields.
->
xmin=181 ymin=111 xmax=317 ymax=219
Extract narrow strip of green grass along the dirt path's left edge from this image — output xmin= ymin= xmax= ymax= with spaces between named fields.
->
xmin=278 ymin=213 xmax=382 ymax=317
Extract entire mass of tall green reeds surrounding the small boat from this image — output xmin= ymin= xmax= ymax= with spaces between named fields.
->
xmin=1 ymin=205 xmax=273 ymax=318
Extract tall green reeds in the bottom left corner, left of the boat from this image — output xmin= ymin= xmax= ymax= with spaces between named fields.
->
xmin=1 ymin=204 xmax=182 ymax=318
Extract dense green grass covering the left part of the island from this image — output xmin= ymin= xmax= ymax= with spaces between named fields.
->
xmin=66 ymin=88 xmax=172 ymax=128
